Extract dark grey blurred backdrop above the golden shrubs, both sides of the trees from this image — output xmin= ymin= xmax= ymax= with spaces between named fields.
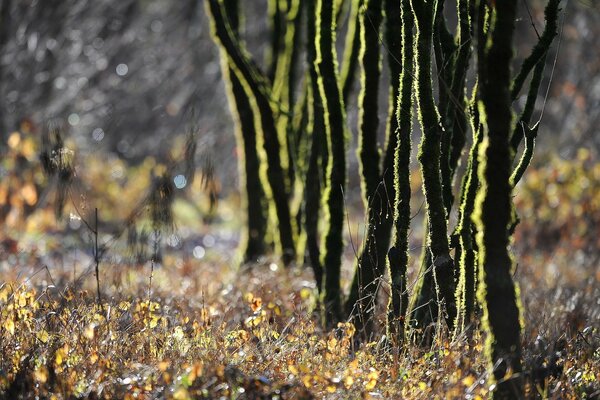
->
xmin=0 ymin=0 xmax=600 ymax=174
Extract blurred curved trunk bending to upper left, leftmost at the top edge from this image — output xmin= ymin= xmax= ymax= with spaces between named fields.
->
xmin=207 ymin=0 xmax=296 ymax=264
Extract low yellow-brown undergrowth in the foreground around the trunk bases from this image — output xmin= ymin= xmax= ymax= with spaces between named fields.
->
xmin=0 ymin=239 xmax=600 ymax=399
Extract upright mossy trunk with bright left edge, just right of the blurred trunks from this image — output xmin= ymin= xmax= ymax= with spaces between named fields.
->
xmin=315 ymin=0 xmax=346 ymax=326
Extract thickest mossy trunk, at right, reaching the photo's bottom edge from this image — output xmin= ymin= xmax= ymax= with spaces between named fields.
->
xmin=474 ymin=0 xmax=524 ymax=399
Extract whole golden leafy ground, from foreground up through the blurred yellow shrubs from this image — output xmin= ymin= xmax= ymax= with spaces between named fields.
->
xmin=0 ymin=136 xmax=600 ymax=399
